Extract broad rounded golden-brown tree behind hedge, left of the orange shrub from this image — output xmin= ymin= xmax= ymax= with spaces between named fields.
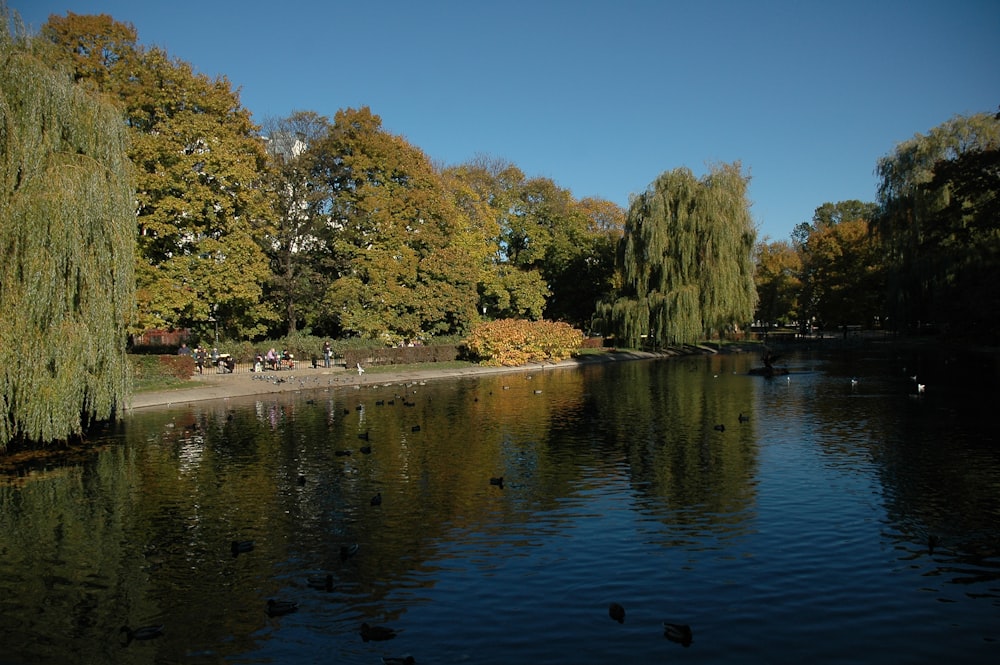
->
xmin=316 ymin=107 xmax=479 ymax=343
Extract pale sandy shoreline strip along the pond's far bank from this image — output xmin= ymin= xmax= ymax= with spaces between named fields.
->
xmin=125 ymin=346 xmax=720 ymax=413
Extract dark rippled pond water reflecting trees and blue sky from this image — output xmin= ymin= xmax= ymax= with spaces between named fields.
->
xmin=0 ymin=350 xmax=1000 ymax=664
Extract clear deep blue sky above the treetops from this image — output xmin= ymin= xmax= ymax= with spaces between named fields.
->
xmin=7 ymin=0 xmax=1000 ymax=240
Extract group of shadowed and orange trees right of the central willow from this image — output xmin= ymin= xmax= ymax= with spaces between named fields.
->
xmin=755 ymin=112 xmax=1000 ymax=344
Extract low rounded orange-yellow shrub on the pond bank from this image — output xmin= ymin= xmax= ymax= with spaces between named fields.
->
xmin=465 ymin=319 xmax=583 ymax=367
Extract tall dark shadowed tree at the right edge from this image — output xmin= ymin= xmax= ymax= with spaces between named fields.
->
xmin=876 ymin=113 xmax=1000 ymax=335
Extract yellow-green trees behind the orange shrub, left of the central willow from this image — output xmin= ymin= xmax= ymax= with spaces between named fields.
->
xmin=443 ymin=157 xmax=624 ymax=325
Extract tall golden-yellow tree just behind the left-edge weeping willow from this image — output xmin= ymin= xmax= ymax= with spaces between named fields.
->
xmin=41 ymin=13 xmax=270 ymax=336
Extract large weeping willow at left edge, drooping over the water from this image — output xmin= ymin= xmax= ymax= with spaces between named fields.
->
xmin=0 ymin=11 xmax=135 ymax=448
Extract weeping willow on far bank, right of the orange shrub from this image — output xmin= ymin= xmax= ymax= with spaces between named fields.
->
xmin=598 ymin=164 xmax=757 ymax=346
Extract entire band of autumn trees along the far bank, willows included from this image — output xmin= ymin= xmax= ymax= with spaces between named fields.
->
xmin=0 ymin=4 xmax=998 ymax=446
